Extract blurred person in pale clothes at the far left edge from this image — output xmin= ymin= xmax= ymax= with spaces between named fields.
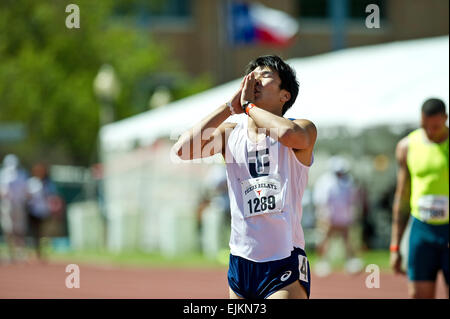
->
xmin=0 ymin=154 xmax=27 ymax=262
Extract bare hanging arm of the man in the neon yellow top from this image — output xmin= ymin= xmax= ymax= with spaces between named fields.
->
xmin=390 ymin=137 xmax=411 ymax=273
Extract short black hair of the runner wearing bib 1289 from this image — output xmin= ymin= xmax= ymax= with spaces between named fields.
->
xmin=245 ymin=55 xmax=299 ymax=115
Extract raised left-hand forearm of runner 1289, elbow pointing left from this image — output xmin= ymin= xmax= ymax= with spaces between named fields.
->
xmin=174 ymin=104 xmax=231 ymax=160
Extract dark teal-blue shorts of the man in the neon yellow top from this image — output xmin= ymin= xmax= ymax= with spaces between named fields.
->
xmin=408 ymin=217 xmax=449 ymax=285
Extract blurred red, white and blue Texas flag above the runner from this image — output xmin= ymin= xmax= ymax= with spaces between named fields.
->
xmin=228 ymin=2 xmax=298 ymax=46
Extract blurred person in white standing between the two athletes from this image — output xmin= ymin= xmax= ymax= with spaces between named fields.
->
xmin=314 ymin=156 xmax=362 ymax=276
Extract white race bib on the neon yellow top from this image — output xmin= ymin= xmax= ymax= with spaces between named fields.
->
xmin=417 ymin=195 xmax=448 ymax=221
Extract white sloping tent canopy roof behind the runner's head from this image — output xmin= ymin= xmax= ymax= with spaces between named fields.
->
xmin=100 ymin=36 xmax=449 ymax=151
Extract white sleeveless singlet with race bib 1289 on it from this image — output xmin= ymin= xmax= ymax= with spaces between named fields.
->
xmin=225 ymin=115 xmax=312 ymax=262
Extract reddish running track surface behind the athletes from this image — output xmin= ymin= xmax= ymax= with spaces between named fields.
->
xmin=0 ymin=262 xmax=447 ymax=299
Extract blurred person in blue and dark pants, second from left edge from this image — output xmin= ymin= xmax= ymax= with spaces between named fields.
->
xmin=27 ymin=163 xmax=63 ymax=260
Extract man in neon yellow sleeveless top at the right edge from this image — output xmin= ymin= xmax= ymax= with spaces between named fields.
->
xmin=390 ymin=99 xmax=449 ymax=298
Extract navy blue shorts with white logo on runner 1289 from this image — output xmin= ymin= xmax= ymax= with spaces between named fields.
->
xmin=228 ymin=248 xmax=311 ymax=299
